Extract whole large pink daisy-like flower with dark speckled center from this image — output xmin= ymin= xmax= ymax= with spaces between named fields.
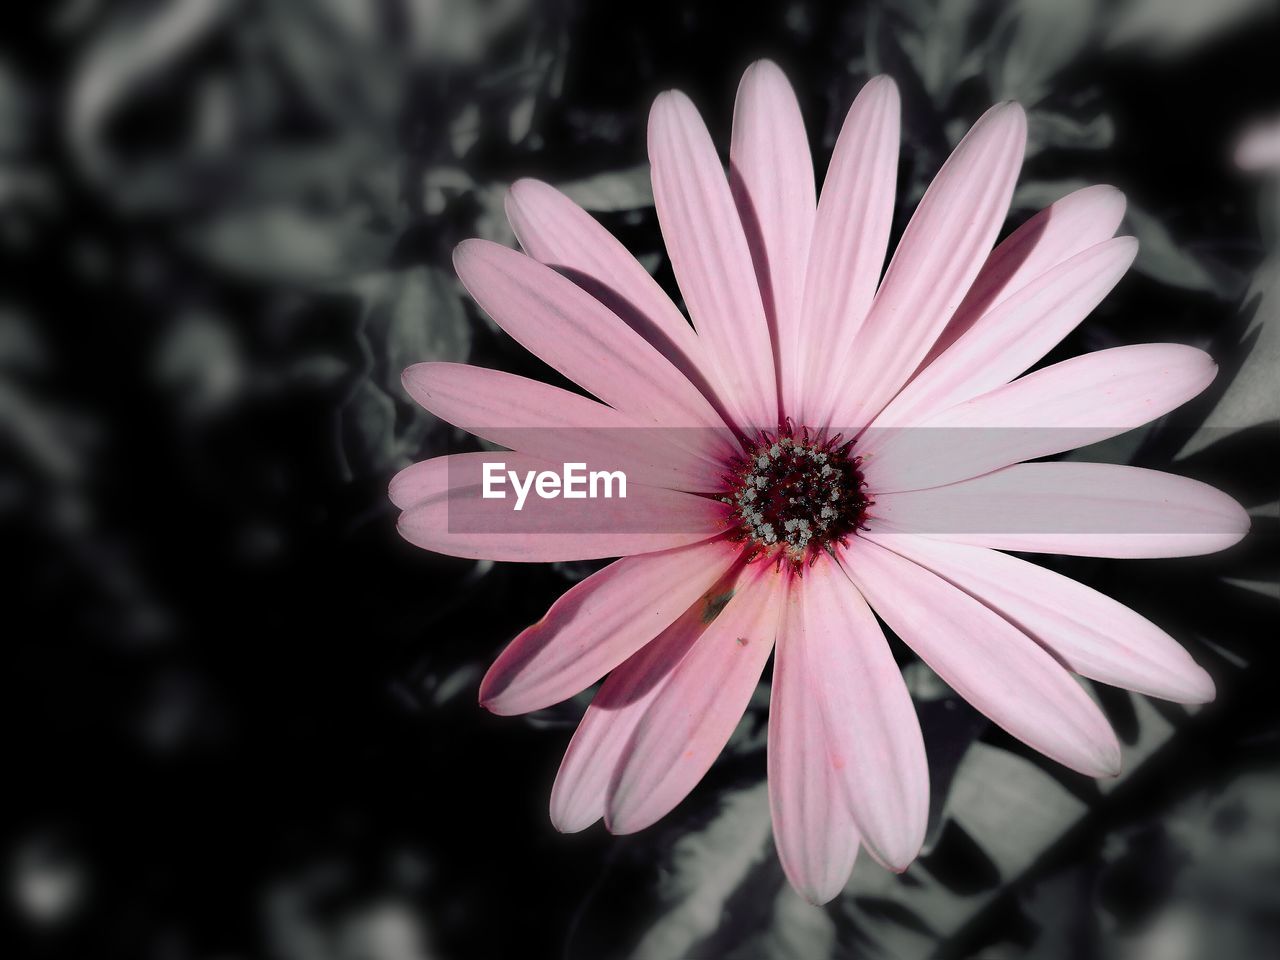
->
xmin=390 ymin=63 xmax=1248 ymax=902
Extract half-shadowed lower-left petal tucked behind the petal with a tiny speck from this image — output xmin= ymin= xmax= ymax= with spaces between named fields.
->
xmin=550 ymin=580 xmax=732 ymax=833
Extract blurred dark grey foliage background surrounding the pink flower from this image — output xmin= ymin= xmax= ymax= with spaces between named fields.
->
xmin=0 ymin=0 xmax=1280 ymax=960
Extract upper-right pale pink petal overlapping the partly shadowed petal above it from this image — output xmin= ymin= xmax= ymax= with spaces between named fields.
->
xmin=874 ymin=237 xmax=1138 ymax=429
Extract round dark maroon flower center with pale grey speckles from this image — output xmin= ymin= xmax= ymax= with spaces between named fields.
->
xmin=721 ymin=422 xmax=872 ymax=571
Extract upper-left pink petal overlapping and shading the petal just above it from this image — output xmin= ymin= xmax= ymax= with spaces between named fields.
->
xmin=453 ymin=239 xmax=723 ymax=440
